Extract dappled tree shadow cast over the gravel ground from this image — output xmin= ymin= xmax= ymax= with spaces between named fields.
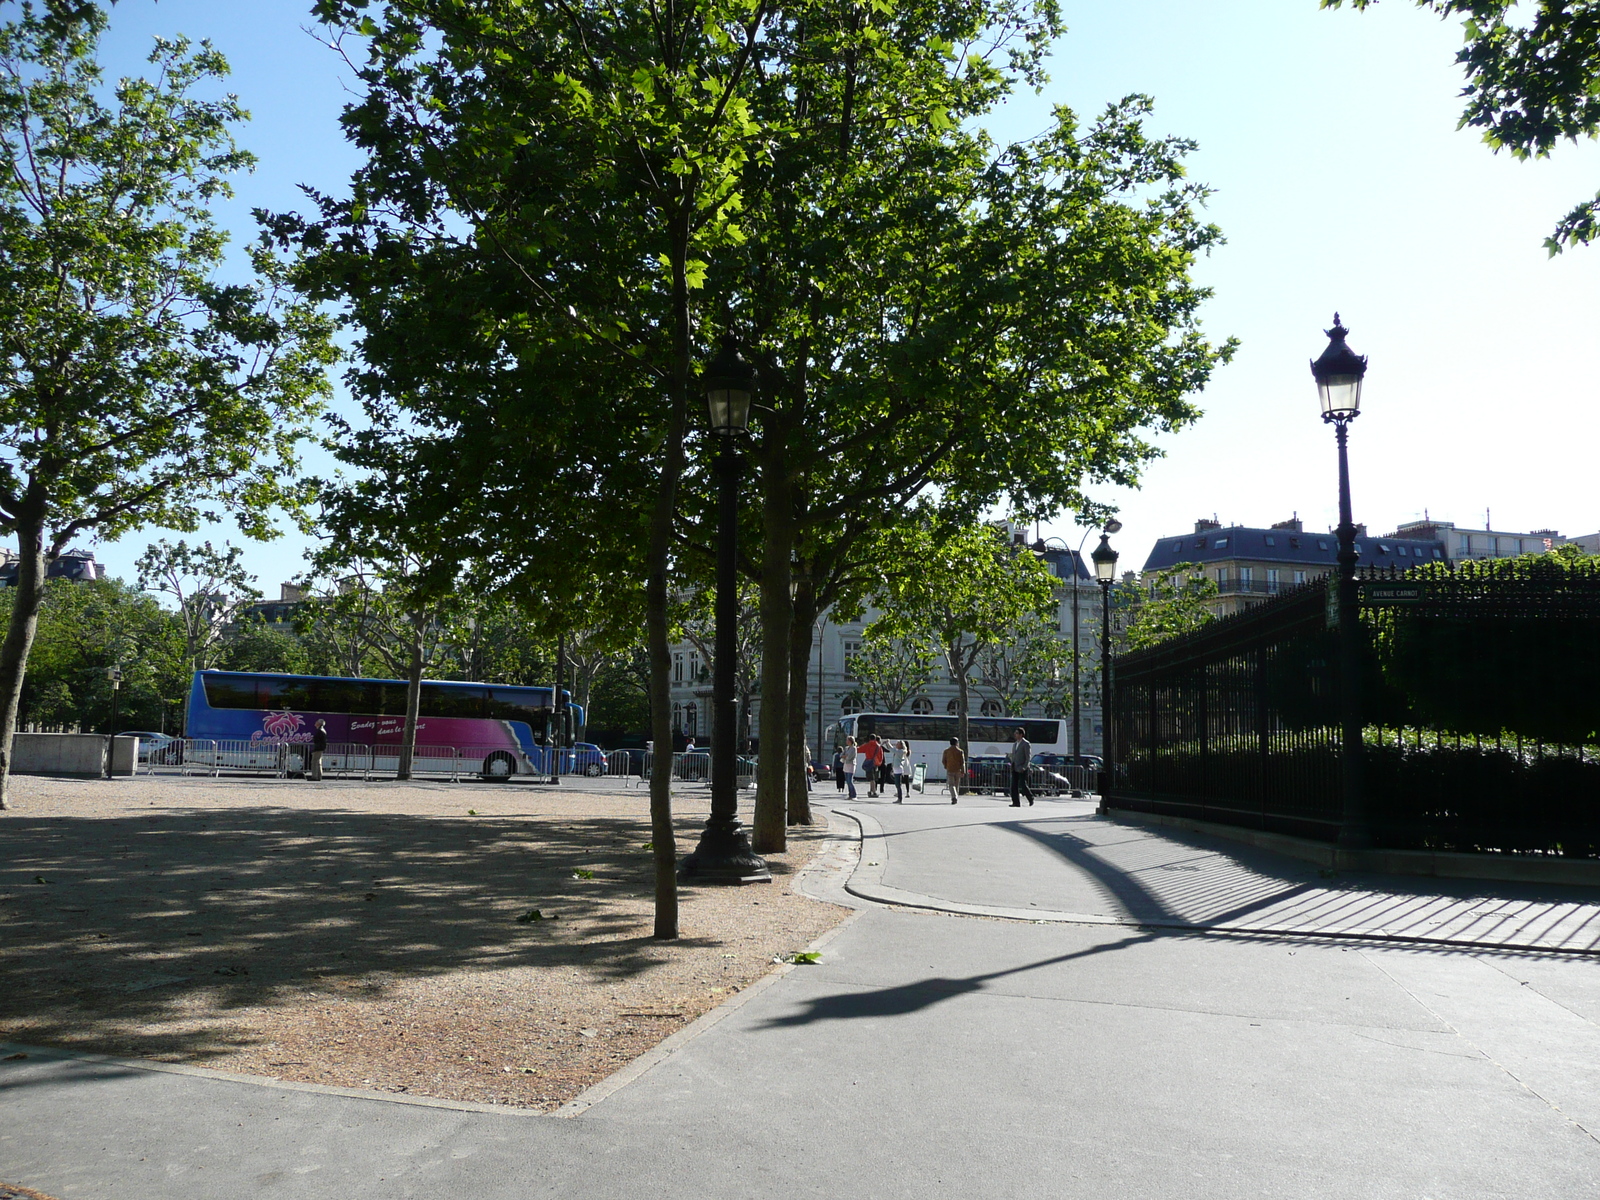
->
xmin=0 ymin=806 xmax=789 ymax=1058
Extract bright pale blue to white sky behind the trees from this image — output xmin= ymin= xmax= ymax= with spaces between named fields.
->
xmin=94 ymin=0 xmax=1600 ymax=595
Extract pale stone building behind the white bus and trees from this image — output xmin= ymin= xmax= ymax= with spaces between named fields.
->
xmin=672 ymin=534 xmax=1102 ymax=757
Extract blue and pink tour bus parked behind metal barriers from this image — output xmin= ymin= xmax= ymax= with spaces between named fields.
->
xmin=186 ymin=670 xmax=605 ymax=779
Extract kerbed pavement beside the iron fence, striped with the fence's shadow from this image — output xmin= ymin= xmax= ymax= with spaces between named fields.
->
xmin=838 ymin=795 xmax=1600 ymax=954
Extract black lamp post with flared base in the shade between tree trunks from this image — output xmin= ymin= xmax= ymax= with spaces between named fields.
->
xmin=678 ymin=333 xmax=773 ymax=883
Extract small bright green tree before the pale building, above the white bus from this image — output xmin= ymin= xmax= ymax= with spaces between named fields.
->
xmin=870 ymin=525 xmax=1056 ymax=749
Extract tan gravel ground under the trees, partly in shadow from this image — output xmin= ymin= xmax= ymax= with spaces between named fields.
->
xmin=0 ymin=776 xmax=848 ymax=1110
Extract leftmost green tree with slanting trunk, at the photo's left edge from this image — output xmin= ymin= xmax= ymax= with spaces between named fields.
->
xmin=0 ymin=3 xmax=333 ymax=808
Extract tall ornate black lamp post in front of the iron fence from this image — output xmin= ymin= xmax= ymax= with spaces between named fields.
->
xmin=1310 ymin=314 xmax=1373 ymax=850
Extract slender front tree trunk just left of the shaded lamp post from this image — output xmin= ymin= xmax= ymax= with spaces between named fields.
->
xmin=645 ymin=209 xmax=690 ymax=938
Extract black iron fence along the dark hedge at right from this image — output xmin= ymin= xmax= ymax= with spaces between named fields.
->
xmin=1106 ymin=560 xmax=1600 ymax=858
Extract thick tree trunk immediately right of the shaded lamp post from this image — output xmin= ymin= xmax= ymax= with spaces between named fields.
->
xmin=750 ymin=451 xmax=795 ymax=854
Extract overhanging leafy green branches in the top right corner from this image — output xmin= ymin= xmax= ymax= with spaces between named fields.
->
xmin=1322 ymin=0 xmax=1600 ymax=254
